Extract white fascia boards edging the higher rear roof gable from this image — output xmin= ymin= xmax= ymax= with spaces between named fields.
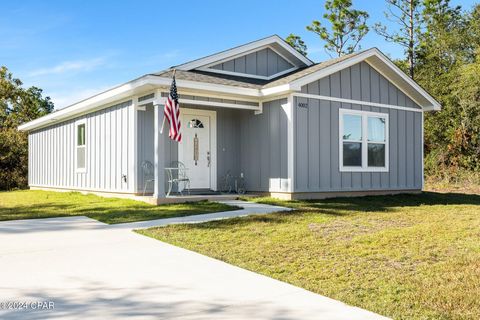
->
xmin=176 ymin=35 xmax=313 ymax=70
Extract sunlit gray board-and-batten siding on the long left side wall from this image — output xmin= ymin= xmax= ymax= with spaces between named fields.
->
xmin=28 ymin=101 xmax=133 ymax=192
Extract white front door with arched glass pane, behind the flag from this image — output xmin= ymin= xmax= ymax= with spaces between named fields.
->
xmin=178 ymin=108 xmax=215 ymax=189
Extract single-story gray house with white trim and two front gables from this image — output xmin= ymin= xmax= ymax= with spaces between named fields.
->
xmin=19 ymin=35 xmax=440 ymax=202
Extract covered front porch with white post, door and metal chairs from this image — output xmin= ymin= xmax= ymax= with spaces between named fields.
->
xmin=135 ymin=90 xmax=274 ymax=204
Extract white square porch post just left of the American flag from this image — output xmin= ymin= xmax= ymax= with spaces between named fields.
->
xmin=157 ymin=98 xmax=165 ymax=199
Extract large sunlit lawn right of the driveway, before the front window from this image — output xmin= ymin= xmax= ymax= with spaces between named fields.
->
xmin=138 ymin=193 xmax=480 ymax=319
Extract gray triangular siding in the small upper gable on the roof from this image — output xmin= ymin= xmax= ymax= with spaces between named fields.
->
xmin=209 ymin=48 xmax=294 ymax=77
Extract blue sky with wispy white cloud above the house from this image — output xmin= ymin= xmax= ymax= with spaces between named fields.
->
xmin=0 ymin=0 xmax=475 ymax=108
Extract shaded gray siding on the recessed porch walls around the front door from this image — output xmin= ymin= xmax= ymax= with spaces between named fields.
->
xmin=137 ymin=96 xmax=288 ymax=192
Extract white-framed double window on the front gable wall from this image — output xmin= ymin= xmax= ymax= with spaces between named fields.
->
xmin=339 ymin=109 xmax=388 ymax=172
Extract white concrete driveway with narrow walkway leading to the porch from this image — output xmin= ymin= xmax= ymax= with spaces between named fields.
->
xmin=0 ymin=204 xmax=384 ymax=320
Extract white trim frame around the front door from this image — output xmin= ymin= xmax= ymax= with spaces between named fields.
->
xmin=178 ymin=108 xmax=217 ymax=191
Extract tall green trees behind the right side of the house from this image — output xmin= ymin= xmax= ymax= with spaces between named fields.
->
xmin=286 ymin=0 xmax=480 ymax=183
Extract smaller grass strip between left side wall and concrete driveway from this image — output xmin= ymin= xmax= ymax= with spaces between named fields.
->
xmin=0 ymin=190 xmax=238 ymax=224
